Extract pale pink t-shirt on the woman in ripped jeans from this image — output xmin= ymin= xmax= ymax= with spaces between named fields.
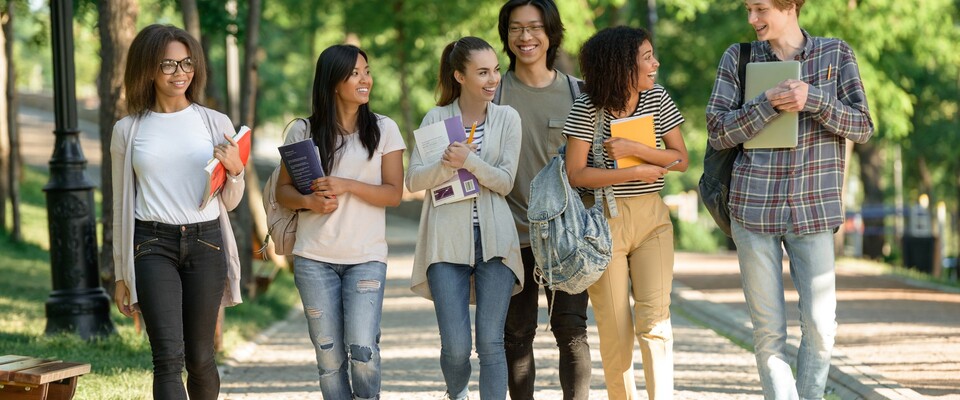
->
xmin=286 ymin=114 xmax=406 ymax=264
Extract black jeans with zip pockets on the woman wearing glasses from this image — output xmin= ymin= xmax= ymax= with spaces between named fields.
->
xmin=133 ymin=220 xmax=227 ymax=400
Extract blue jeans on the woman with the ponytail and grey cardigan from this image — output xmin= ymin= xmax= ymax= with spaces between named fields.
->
xmin=427 ymin=228 xmax=517 ymax=400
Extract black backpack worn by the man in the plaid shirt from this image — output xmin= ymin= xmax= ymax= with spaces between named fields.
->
xmin=699 ymin=43 xmax=751 ymax=237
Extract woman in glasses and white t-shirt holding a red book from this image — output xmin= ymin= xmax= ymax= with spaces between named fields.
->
xmin=110 ymin=25 xmax=244 ymax=400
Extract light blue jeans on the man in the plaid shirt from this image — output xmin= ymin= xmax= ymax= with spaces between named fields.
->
xmin=731 ymin=221 xmax=837 ymax=400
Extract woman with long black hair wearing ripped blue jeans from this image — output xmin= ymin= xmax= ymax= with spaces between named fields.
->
xmin=276 ymin=45 xmax=405 ymax=399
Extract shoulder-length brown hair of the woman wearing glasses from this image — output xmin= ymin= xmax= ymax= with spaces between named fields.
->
xmin=123 ymin=24 xmax=207 ymax=116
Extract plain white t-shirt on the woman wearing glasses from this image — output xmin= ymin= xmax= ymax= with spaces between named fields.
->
xmin=133 ymin=107 xmax=220 ymax=225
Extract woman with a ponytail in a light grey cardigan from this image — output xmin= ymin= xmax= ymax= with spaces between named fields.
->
xmin=406 ymin=37 xmax=523 ymax=400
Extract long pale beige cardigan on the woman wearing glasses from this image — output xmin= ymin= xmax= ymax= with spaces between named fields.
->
xmin=110 ymin=104 xmax=245 ymax=307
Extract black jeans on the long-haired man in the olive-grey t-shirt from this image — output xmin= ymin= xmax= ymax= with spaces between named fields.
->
xmin=503 ymin=247 xmax=591 ymax=400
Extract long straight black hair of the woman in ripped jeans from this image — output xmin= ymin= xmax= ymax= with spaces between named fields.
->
xmin=309 ymin=44 xmax=380 ymax=174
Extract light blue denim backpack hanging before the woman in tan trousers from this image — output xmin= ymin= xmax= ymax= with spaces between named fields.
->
xmin=527 ymin=110 xmax=618 ymax=294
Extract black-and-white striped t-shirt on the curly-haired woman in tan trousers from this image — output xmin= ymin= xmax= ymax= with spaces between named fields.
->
xmin=563 ymin=85 xmax=684 ymax=197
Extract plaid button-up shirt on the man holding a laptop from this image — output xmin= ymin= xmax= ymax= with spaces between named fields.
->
xmin=707 ymin=31 xmax=873 ymax=235
